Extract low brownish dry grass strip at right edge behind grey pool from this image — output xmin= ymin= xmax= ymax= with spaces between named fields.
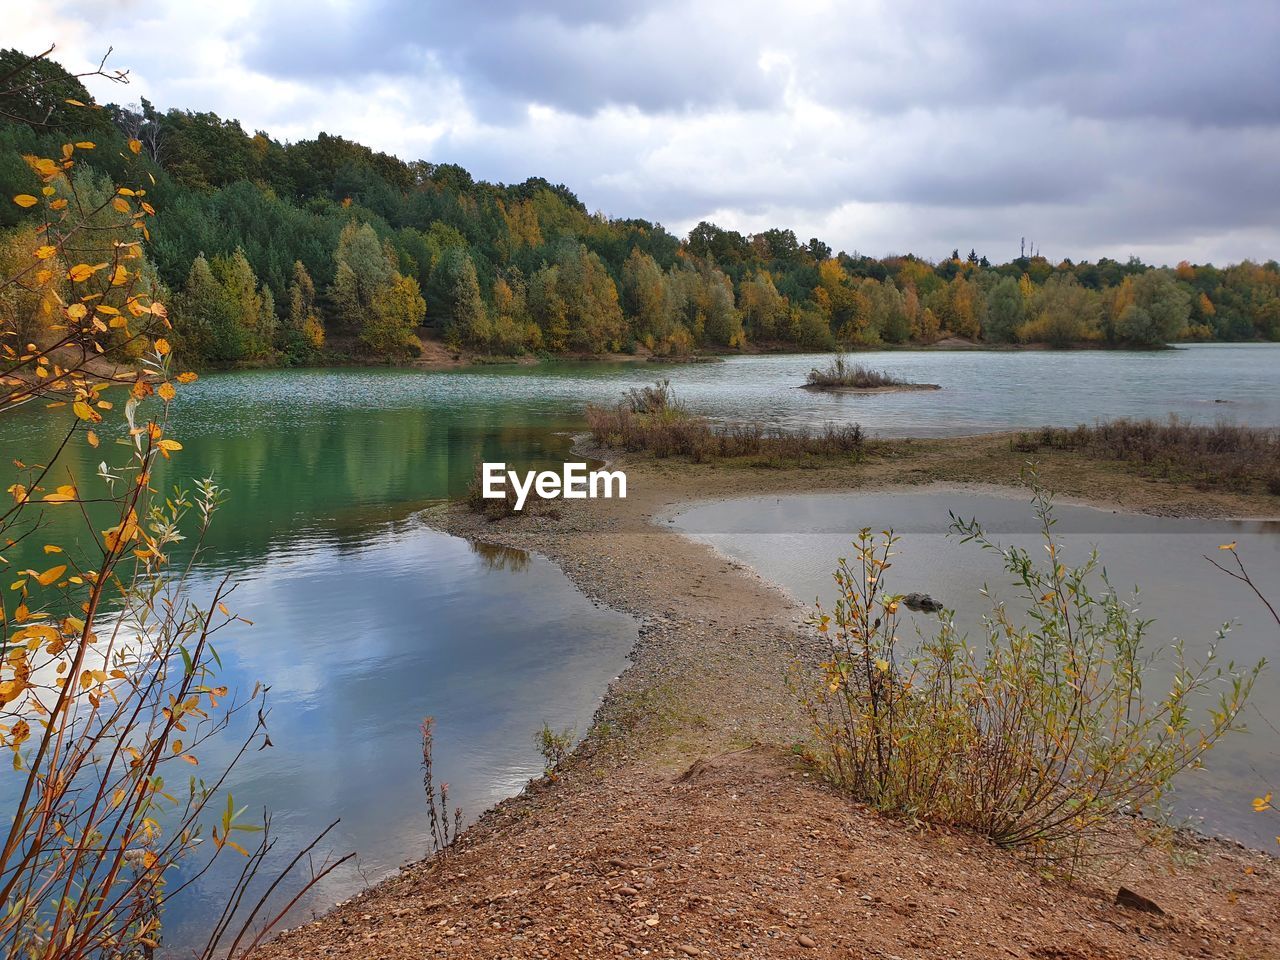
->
xmin=1014 ymin=417 xmax=1280 ymax=495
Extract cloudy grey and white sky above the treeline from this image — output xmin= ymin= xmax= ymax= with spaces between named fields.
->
xmin=10 ymin=0 xmax=1280 ymax=262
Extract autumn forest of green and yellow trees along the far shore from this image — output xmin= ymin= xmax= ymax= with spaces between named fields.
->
xmin=0 ymin=50 xmax=1280 ymax=367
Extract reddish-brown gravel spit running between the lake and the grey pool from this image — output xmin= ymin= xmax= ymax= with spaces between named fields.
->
xmin=266 ymin=436 xmax=1280 ymax=960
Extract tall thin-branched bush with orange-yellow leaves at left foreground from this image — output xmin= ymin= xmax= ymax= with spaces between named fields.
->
xmin=0 ymin=50 xmax=350 ymax=960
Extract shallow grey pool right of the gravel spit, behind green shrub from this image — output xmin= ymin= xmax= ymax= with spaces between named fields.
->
xmin=675 ymin=492 xmax=1280 ymax=849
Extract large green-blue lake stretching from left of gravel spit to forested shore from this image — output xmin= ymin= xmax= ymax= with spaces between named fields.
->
xmin=0 ymin=346 xmax=1280 ymax=936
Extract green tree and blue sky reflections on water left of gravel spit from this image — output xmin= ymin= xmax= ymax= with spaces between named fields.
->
xmin=0 ymin=391 xmax=636 ymax=950
